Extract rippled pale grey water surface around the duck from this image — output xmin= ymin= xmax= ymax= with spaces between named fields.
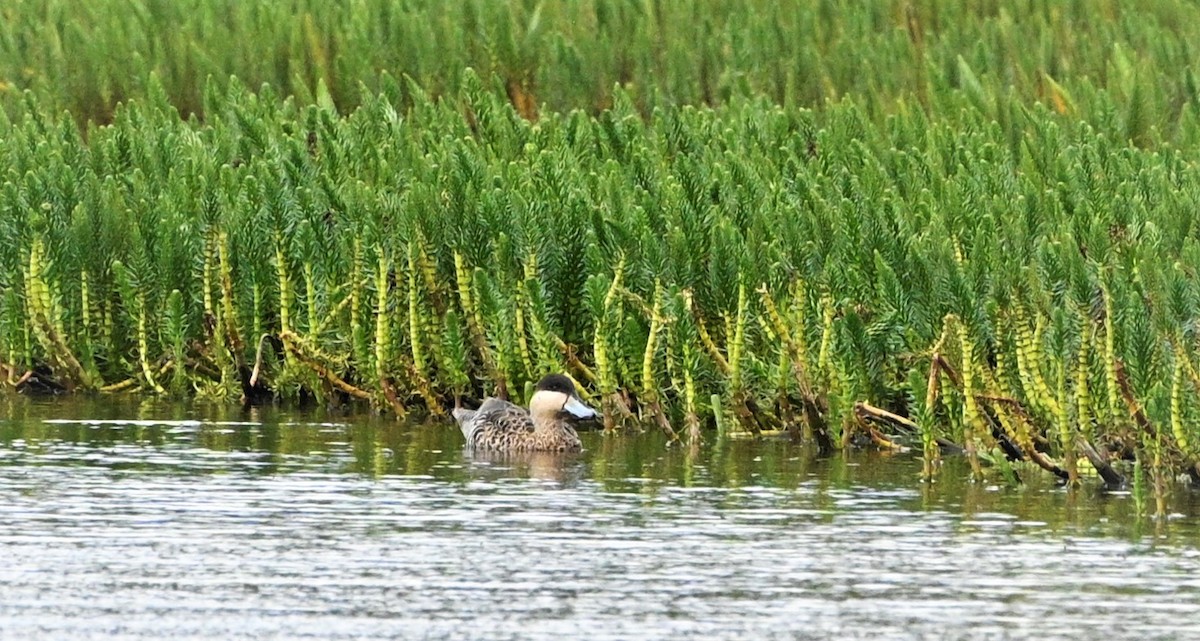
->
xmin=0 ymin=397 xmax=1200 ymax=640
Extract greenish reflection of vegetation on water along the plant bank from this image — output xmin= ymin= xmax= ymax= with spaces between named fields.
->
xmin=7 ymin=400 xmax=1200 ymax=543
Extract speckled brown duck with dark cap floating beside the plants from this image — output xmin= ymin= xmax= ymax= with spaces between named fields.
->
xmin=454 ymin=373 xmax=598 ymax=451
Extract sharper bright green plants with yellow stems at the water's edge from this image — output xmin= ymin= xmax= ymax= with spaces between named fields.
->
xmin=0 ymin=42 xmax=1200 ymax=492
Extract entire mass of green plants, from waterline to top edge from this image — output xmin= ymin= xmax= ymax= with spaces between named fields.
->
xmin=0 ymin=0 xmax=1200 ymax=492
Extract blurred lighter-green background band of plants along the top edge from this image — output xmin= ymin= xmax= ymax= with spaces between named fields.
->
xmin=7 ymin=0 xmax=1200 ymax=139
